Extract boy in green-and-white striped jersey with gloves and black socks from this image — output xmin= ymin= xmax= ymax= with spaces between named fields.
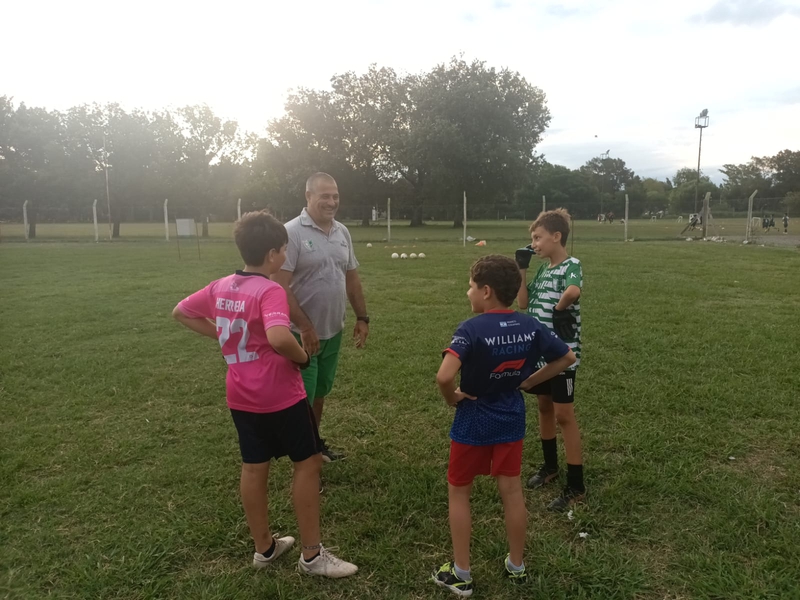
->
xmin=515 ymin=208 xmax=586 ymax=511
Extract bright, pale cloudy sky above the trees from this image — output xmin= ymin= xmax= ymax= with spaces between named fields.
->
xmin=0 ymin=0 xmax=800 ymax=181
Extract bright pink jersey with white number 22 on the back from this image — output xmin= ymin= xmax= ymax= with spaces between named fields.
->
xmin=178 ymin=271 xmax=306 ymax=413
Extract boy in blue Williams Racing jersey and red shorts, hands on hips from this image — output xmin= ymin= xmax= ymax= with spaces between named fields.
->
xmin=433 ymin=255 xmax=575 ymax=597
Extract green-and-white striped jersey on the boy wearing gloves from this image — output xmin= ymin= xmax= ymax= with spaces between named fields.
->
xmin=528 ymin=256 xmax=583 ymax=371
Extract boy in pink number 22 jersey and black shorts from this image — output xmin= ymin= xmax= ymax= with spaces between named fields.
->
xmin=172 ymin=211 xmax=358 ymax=578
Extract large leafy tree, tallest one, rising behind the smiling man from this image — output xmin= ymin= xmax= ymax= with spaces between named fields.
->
xmin=262 ymin=58 xmax=550 ymax=225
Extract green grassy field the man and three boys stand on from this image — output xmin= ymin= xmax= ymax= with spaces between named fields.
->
xmin=0 ymin=232 xmax=800 ymax=600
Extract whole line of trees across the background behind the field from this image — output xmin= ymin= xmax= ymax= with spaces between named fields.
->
xmin=0 ymin=57 xmax=800 ymax=236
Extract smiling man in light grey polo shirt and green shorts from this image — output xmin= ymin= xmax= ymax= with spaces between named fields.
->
xmin=272 ymin=173 xmax=369 ymax=462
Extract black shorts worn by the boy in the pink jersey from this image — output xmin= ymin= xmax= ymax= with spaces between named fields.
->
xmin=231 ymin=398 xmax=322 ymax=463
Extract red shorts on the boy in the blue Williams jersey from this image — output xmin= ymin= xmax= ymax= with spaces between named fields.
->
xmin=447 ymin=440 xmax=522 ymax=487
